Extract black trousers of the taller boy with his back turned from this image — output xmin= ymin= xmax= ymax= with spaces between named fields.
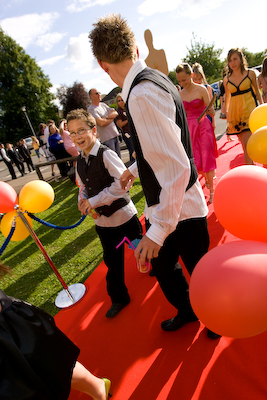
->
xmin=148 ymin=218 xmax=209 ymax=318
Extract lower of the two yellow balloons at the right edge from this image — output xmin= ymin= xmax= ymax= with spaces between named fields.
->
xmin=247 ymin=126 xmax=267 ymax=164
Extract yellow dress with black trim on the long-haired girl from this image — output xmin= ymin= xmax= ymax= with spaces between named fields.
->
xmin=226 ymin=74 xmax=257 ymax=135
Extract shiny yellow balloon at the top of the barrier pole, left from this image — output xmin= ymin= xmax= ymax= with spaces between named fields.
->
xmin=19 ymin=180 xmax=55 ymax=213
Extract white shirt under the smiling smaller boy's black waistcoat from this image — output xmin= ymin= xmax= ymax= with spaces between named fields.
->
xmin=76 ymin=139 xmax=137 ymax=227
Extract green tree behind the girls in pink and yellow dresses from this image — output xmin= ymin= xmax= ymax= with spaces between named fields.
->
xmin=183 ymin=33 xmax=224 ymax=83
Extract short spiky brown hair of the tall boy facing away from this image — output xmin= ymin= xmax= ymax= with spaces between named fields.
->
xmin=89 ymin=14 xmax=137 ymax=64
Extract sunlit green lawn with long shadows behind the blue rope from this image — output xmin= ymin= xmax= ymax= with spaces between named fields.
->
xmin=0 ymin=179 xmax=145 ymax=316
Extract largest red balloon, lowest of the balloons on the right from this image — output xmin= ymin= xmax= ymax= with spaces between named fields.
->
xmin=189 ymin=241 xmax=267 ymax=338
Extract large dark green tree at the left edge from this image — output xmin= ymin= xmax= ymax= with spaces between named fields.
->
xmin=0 ymin=28 xmax=59 ymax=143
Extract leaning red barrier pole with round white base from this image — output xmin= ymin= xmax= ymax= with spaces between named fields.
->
xmin=17 ymin=207 xmax=86 ymax=308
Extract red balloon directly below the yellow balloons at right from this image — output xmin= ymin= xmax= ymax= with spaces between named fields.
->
xmin=213 ymin=165 xmax=267 ymax=242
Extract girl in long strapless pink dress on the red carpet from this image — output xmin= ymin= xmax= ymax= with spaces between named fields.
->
xmin=176 ymin=63 xmax=216 ymax=203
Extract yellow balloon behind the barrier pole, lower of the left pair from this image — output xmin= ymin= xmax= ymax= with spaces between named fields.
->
xmin=1 ymin=211 xmax=32 ymax=242
